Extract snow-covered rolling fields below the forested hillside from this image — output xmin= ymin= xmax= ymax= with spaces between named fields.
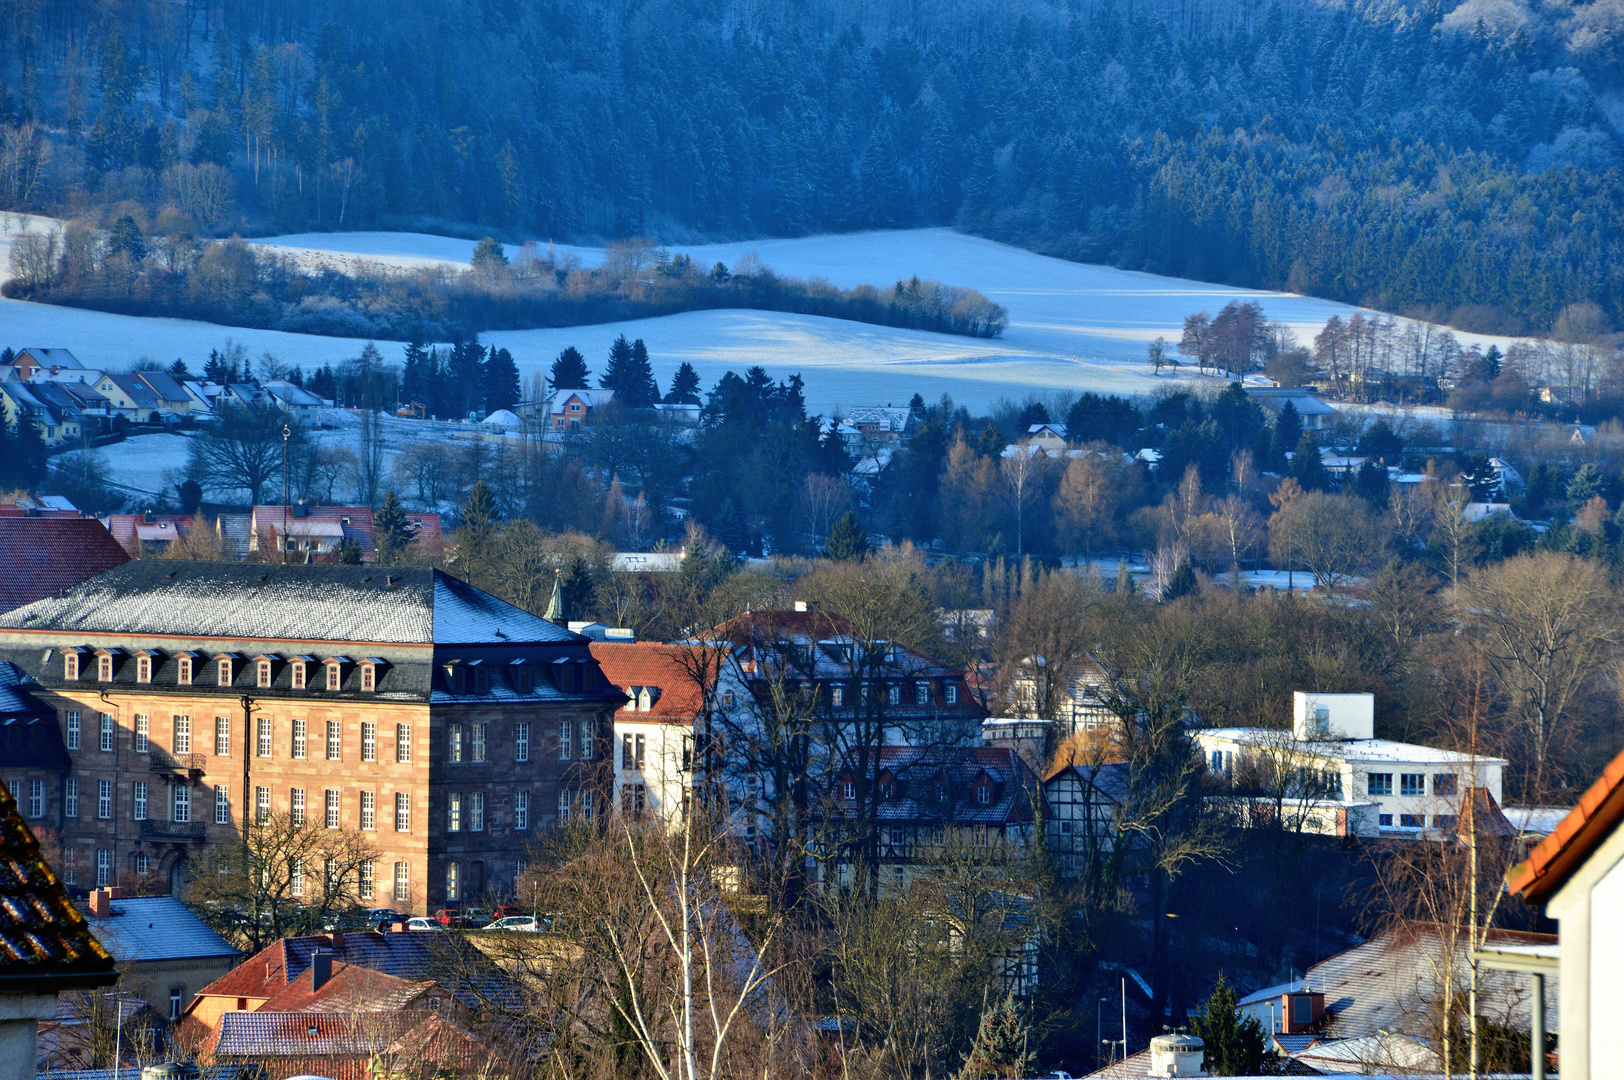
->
xmin=0 ymin=218 xmax=1526 ymax=411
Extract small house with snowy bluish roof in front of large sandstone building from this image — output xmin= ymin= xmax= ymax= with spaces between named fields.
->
xmin=86 ymin=888 xmax=242 ymax=1022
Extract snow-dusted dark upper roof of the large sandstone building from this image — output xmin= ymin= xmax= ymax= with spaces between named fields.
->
xmin=0 ymin=558 xmax=583 ymax=645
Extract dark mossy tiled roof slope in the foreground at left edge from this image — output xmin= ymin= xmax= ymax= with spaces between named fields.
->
xmin=0 ymin=786 xmax=119 ymax=994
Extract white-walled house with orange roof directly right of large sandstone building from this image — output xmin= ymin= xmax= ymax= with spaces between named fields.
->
xmin=591 ymin=642 xmax=705 ymax=822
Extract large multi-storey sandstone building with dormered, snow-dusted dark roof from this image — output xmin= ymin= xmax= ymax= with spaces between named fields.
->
xmin=0 ymin=560 xmax=625 ymax=911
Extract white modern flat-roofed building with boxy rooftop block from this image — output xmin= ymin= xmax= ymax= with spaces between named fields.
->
xmin=1194 ymin=690 xmax=1507 ymax=836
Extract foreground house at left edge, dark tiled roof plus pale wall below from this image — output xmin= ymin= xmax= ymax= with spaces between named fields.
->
xmin=0 ymin=779 xmax=119 ymax=1080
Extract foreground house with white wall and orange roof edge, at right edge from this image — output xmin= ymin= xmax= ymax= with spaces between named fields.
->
xmin=1488 ymin=740 xmax=1624 ymax=1080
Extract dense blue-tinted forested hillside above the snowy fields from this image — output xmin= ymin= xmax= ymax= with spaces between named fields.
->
xmin=0 ymin=0 xmax=1624 ymax=331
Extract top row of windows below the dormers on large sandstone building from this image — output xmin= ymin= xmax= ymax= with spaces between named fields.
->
xmin=67 ymin=710 xmax=594 ymax=765
